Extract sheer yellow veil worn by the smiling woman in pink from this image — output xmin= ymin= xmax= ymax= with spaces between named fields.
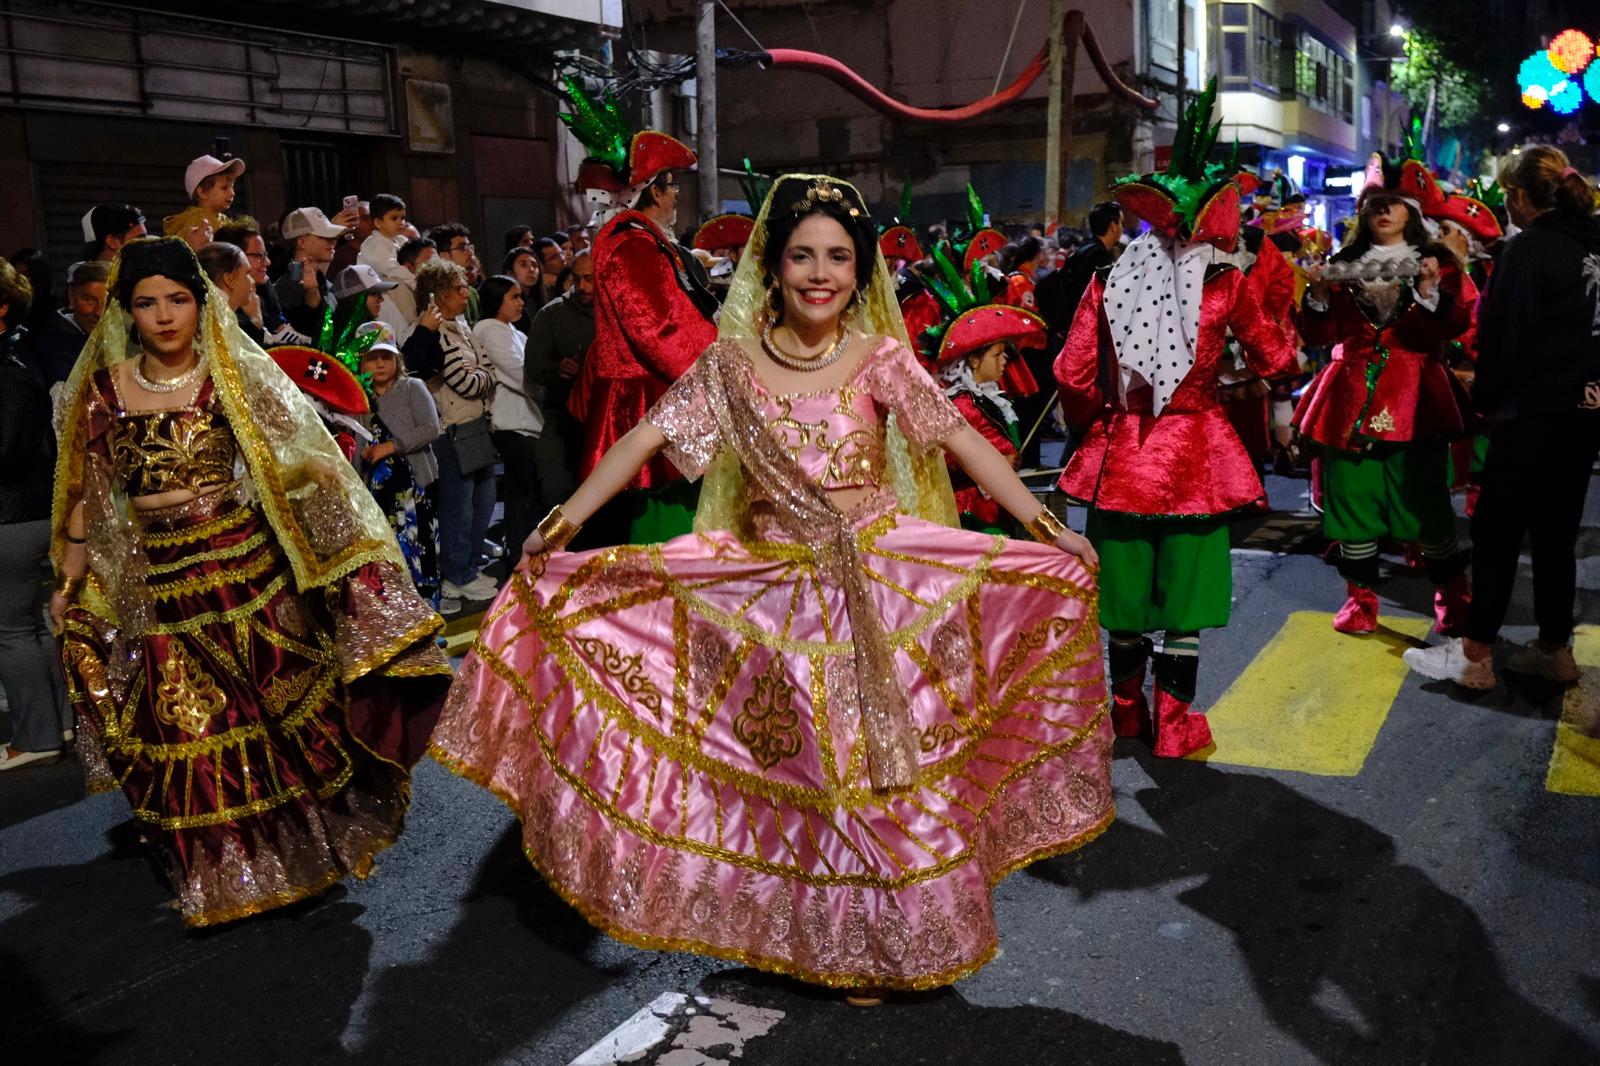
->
xmin=694 ymin=174 xmax=960 ymax=531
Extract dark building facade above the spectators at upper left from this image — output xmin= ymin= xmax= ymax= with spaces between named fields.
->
xmin=0 ymin=0 xmax=621 ymax=275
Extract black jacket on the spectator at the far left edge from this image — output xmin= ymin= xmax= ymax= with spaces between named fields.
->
xmin=0 ymin=327 xmax=56 ymax=523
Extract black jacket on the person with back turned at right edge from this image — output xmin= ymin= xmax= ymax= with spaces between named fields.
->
xmin=1472 ymin=211 xmax=1600 ymax=421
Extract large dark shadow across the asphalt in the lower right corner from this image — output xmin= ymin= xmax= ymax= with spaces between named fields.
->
xmin=1029 ymin=752 xmax=1600 ymax=1066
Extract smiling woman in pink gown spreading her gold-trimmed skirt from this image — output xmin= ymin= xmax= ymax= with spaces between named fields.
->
xmin=434 ymin=174 xmax=1114 ymax=989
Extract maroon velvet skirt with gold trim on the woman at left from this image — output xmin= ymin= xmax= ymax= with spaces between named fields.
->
xmin=62 ymin=491 xmax=450 ymax=927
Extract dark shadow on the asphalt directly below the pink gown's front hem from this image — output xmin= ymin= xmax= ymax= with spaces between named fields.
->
xmin=694 ymin=970 xmax=1184 ymax=1066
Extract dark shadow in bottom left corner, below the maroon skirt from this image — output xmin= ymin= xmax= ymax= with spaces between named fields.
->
xmin=0 ymin=855 xmax=371 ymax=1066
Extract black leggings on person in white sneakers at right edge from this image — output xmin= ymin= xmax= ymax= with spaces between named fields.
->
xmin=1466 ymin=411 xmax=1600 ymax=643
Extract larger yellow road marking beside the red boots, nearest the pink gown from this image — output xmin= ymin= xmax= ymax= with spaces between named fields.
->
xmin=1189 ymin=611 xmax=1434 ymax=776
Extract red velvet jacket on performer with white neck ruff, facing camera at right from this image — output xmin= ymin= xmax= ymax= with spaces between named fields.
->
xmin=1294 ymin=267 xmax=1478 ymax=451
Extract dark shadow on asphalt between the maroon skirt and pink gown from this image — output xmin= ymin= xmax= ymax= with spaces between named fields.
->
xmin=346 ymin=821 xmax=613 ymax=1066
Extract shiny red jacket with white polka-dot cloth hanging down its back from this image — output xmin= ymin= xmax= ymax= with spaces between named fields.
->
xmin=1054 ymin=267 xmax=1294 ymax=517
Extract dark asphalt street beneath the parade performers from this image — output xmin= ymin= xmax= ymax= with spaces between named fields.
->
xmin=0 ymin=480 xmax=1600 ymax=1066
